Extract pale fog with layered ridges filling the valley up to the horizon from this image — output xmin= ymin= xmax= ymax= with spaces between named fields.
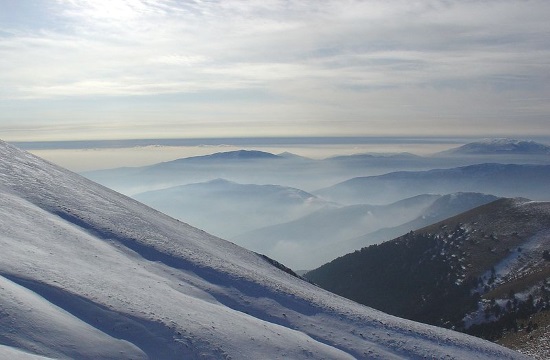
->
xmin=23 ymin=138 xmax=550 ymax=270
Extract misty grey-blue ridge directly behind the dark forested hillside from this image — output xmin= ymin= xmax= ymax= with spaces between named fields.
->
xmin=237 ymin=193 xmax=496 ymax=269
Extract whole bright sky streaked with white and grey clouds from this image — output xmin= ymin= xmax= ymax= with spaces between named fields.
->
xmin=0 ymin=0 xmax=550 ymax=141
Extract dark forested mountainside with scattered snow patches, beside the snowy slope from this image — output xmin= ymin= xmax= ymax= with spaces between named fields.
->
xmin=306 ymin=199 xmax=550 ymax=358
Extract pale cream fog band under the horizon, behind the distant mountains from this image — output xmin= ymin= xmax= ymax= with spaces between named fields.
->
xmin=23 ymin=139 xmax=460 ymax=172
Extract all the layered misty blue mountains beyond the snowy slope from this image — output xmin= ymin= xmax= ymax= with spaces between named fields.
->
xmin=80 ymin=140 xmax=550 ymax=269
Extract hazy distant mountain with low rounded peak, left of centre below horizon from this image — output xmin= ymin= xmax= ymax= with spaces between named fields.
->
xmin=82 ymin=150 xmax=345 ymax=195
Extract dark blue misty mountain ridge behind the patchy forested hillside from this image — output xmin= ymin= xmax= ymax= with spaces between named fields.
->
xmin=313 ymin=164 xmax=550 ymax=204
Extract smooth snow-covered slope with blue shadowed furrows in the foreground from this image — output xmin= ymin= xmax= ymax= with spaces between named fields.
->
xmin=0 ymin=143 xmax=522 ymax=359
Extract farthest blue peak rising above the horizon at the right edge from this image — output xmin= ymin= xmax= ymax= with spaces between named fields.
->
xmin=436 ymin=139 xmax=550 ymax=155
